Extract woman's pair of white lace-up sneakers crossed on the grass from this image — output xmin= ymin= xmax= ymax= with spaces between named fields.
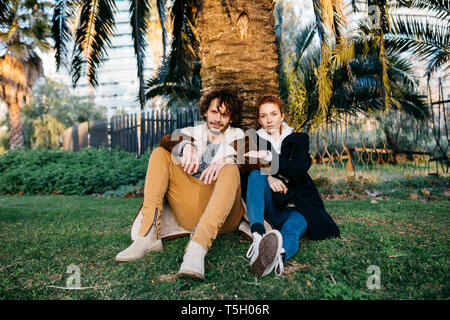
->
xmin=249 ymin=230 xmax=284 ymax=277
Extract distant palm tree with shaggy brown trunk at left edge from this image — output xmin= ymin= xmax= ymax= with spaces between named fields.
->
xmin=0 ymin=0 xmax=50 ymax=150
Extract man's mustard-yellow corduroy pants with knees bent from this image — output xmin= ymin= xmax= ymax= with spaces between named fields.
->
xmin=139 ymin=147 xmax=244 ymax=251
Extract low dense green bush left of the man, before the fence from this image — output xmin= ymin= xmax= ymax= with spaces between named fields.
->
xmin=0 ymin=148 xmax=150 ymax=195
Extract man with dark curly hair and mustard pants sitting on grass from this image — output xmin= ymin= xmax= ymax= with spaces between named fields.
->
xmin=115 ymin=90 xmax=244 ymax=279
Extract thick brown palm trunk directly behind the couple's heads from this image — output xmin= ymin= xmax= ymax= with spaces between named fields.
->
xmin=197 ymin=0 xmax=279 ymax=128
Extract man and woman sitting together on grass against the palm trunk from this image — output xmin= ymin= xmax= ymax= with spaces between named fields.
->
xmin=115 ymin=90 xmax=339 ymax=279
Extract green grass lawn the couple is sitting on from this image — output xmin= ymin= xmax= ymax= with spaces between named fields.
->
xmin=0 ymin=196 xmax=450 ymax=299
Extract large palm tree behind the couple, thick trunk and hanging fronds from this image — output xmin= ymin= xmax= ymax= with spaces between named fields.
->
xmin=57 ymin=0 xmax=408 ymax=129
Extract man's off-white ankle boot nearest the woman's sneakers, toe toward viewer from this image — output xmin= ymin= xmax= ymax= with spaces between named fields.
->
xmin=178 ymin=240 xmax=206 ymax=280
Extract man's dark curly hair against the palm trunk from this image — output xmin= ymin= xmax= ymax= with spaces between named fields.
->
xmin=200 ymin=89 xmax=242 ymax=127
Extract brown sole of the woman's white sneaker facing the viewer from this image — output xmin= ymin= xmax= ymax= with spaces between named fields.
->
xmin=250 ymin=231 xmax=282 ymax=276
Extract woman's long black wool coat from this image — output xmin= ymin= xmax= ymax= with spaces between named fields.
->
xmin=250 ymin=132 xmax=340 ymax=240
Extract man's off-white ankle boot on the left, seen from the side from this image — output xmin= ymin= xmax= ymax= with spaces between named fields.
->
xmin=115 ymin=227 xmax=163 ymax=261
